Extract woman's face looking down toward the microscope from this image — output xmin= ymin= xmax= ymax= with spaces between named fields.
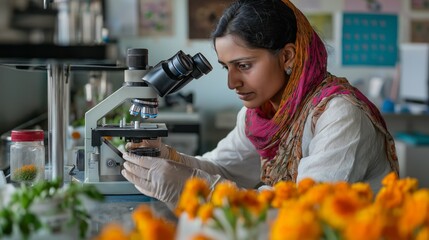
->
xmin=215 ymin=35 xmax=287 ymax=110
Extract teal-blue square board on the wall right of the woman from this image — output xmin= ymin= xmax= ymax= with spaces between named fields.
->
xmin=341 ymin=13 xmax=398 ymax=66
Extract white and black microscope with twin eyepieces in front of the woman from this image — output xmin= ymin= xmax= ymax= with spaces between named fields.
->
xmin=84 ymin=48 xmax=212 ymax=194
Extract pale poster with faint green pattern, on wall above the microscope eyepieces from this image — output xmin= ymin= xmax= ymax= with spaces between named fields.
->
xmin=139 ymin=0 xmax=173 ymax=36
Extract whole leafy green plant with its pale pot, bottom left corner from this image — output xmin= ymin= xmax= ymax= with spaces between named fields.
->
xmin=0 ymin=180 xmax=103 ymax=240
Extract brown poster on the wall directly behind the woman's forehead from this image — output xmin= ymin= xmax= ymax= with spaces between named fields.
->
xmin=188 ymin=0 xmax=233 ymax=39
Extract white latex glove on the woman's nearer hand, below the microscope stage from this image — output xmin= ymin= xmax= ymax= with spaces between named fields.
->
xmin=121 ymin=153 xmax=221 ymax=209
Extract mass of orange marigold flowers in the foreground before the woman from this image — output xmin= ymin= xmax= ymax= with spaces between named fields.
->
xmin=94 ymin=173 xmax=429 ymax=240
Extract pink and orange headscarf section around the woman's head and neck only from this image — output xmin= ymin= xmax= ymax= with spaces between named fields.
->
xmin=247 ymin=1 xmax=327 ymax=158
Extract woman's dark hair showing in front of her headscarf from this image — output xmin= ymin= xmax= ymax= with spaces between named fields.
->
xmin=211 ymin=0 xmax=297 ymax=51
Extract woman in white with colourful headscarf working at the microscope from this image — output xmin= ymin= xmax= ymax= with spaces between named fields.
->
xmin=119 ymin=0 xmax=398 ymax=205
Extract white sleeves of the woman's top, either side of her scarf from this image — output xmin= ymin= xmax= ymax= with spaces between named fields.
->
xmin=197 ymin=96 xmax=391 ymax=192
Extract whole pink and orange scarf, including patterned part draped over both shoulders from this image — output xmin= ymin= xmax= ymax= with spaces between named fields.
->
xmin=246 ymin=0 xmax=398 ymax=185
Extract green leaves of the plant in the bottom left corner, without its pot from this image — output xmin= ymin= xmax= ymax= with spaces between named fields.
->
xmin=0 ymin=179 xmax=104 ymax=239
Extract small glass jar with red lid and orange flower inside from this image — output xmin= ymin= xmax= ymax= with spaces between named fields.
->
xmin=10 ymin=130 xmax=45 ymax=185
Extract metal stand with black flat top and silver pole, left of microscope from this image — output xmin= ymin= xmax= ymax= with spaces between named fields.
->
xmin=0 ymin=44 xmax=125 ymax=184
